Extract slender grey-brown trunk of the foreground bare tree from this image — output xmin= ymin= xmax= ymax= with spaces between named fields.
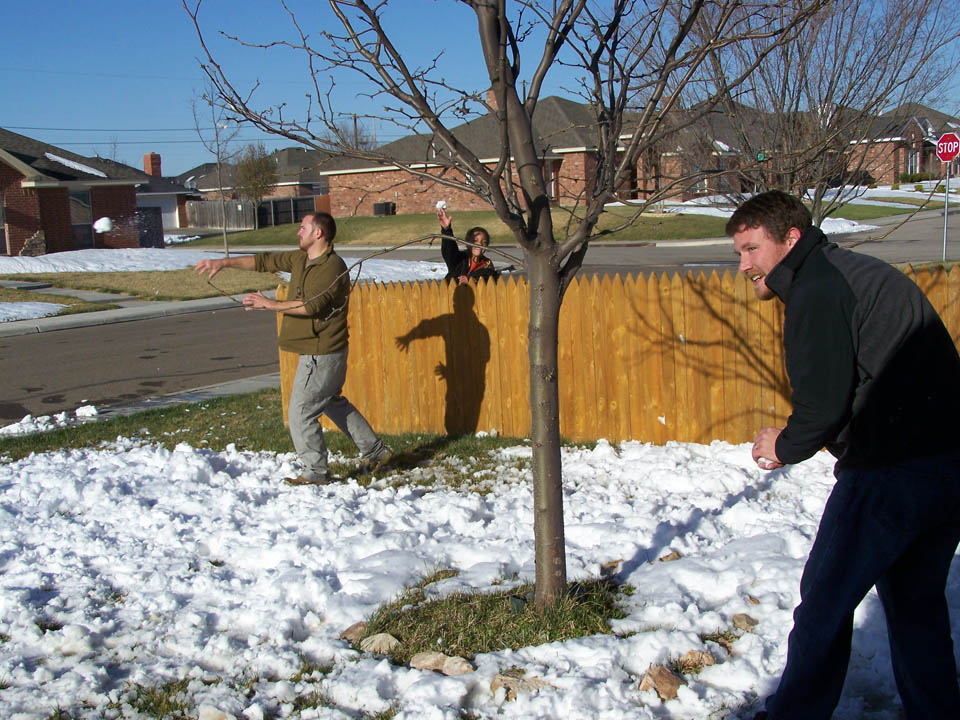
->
xmin=527 ymin=248 xmax=567 ymax=609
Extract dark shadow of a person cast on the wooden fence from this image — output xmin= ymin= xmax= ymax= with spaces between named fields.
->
xmin=396 ymin=283 xmax=490 ymax=437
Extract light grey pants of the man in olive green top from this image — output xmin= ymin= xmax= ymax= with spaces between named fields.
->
xmin=287 ymin=348 xmax=386 ymax=480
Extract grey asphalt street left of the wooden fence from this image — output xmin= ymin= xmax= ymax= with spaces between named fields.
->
xmin=0 ymin=308 xmax=278 ymax=425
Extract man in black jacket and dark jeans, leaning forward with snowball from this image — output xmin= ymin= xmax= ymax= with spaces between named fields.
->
xmin=726 ymin=191 xmax=960 ymax=720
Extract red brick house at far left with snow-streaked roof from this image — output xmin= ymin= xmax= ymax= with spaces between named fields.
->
xmin=0 ymin=128 xmax=140 ymax=255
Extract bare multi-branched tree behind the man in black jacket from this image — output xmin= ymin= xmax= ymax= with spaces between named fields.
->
xmin=711 ymin=0 xmax=960 ymax=223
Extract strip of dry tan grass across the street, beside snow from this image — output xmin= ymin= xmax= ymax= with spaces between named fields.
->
xmin=4 ymin=268 xmax=280 ymax=300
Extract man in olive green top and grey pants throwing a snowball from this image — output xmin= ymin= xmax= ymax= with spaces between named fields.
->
xmin=196 ymin=212 xmax=390 ymax=485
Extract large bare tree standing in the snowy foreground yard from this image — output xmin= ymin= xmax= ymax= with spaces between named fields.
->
xmin=184 ymin=0 xmax=820 ymax=607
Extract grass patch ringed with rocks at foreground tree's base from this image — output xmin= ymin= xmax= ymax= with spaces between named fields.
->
xmin=356 ymin=570 xmax=625 ymax=664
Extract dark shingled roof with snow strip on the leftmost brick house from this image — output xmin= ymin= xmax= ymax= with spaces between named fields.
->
xmin=0 ymin=128 xmax=143 ymax=187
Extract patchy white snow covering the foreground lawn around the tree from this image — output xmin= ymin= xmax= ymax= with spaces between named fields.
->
xmin=0 ymin=430 xmax=960 ymax=720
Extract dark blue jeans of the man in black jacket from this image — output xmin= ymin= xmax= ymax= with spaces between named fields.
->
xmin=766 ymin=453 xmax=960 ymax=720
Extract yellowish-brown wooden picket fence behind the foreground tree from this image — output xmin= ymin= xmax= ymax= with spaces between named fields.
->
xmin=280 ymin=267 xmax=960 ymax=444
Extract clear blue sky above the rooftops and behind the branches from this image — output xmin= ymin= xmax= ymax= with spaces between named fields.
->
xmin=0 ymin=0 xmax=960 ymax=175
